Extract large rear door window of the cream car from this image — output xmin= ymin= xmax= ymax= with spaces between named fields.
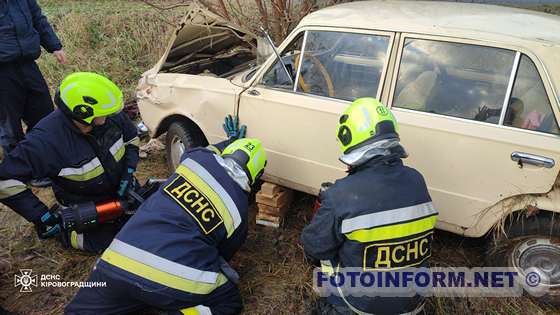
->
xmin=393 ymin=39 xmax=515 ymax=124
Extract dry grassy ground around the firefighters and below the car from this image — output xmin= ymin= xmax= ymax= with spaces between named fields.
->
xmin=0 ymin=152 xmax=558 ymax=315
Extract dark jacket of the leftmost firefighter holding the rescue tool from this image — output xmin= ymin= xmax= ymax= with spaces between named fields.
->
xmin=0 ymin=109 xmax=140 ymax=222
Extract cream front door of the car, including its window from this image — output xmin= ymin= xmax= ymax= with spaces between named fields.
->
xmin=239 ymin=28 xmax=393 ymax=193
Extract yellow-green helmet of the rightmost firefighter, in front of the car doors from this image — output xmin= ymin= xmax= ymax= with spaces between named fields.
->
xmin=336 ymin=97 xmax=398 ymax=154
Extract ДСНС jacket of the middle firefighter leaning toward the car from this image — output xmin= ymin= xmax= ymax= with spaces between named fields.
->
xmin=97 ymin=141 xmax=248 ymax=306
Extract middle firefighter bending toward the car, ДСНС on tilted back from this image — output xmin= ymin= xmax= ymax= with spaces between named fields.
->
xmin=65 ymin=139 xmax=266 ymax=315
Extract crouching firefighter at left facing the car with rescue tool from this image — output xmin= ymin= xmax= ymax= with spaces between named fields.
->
xmin=0 ymin=72 xmax=139 ymax=252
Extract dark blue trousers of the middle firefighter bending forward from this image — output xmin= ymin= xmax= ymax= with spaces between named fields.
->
xmin=64 ymin=265 xmax=243 ymax=315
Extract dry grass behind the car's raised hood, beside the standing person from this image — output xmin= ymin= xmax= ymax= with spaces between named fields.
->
xmin=39 ymin=0 xmax=182 ymax=99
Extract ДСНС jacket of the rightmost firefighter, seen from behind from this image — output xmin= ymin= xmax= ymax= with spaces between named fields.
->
xmin=302 ymin=154 xmax=437 ymax=314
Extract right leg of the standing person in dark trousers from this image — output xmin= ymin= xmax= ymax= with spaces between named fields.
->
xmin=21 ymin=61 xmax=53 ymax=131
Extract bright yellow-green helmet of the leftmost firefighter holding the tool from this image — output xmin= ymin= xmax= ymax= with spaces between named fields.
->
xmin=55 ymin=72 xmax=123 ymax=125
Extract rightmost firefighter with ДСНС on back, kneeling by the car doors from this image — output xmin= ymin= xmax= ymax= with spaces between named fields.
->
xmin=302 ymin=98 xmax=437 ymax=314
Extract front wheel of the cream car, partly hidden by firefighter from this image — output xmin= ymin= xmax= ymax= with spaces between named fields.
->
xmin=165 ymin=121 xmax=204 ymax=173
